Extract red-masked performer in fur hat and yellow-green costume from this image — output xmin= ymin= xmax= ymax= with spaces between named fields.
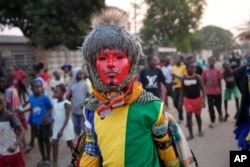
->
xmin=72 ymin=7 xmax=195 ymax=167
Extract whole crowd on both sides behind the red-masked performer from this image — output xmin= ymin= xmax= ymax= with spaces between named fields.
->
xmin=0 ymin=45 xmax=248 ymax=167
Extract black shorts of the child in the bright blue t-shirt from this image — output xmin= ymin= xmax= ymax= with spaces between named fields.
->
xmin=31 ymin=124 xmax=52 ymax=139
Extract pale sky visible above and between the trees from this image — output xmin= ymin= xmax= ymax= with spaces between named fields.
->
xmin=0 ymin=0 xmax=250 ymax=35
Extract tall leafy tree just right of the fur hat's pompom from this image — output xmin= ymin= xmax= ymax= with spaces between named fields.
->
xmin=141 ymin=0 xmax=205 ymax=45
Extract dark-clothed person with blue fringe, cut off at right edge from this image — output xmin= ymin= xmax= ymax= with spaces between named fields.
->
xmin=234 ymin=54 xmax=250 ymax=151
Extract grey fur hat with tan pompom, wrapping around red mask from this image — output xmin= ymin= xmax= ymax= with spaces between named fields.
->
xmin=82 ymin=7 xmax=143 ymax=92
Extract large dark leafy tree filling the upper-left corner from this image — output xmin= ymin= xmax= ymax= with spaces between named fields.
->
xmin=0 ymin=0 xmax=104 ymax=49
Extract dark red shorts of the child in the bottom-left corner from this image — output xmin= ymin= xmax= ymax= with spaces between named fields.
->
xmin=0 ymin=150 xmax=25 ymax=167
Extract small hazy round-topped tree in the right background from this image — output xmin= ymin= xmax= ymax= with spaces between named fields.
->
xmin=199 ymin=25 xmax=235 ymax=56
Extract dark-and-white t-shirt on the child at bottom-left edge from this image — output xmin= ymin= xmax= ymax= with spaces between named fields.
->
xmin=0 ymin=111 xmax=21 ymax=155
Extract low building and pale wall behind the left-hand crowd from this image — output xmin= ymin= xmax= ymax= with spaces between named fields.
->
xmin=0 ymin=35 xmax=83 ymax=72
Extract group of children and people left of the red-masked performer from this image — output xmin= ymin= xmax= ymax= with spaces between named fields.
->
xmin=0 ymin=63 xmax=93 ymax=167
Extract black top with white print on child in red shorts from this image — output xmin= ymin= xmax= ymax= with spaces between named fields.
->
xmin=182 ymin=74 xmax=200 ymax=99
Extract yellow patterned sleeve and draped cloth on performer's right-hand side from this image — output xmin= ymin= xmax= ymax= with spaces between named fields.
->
xmin=152 ymin=103 xmax=192 ymax=167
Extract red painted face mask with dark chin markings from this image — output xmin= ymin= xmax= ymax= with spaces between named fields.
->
xmin=95 ymin=48 xmax=131 ymax=86
